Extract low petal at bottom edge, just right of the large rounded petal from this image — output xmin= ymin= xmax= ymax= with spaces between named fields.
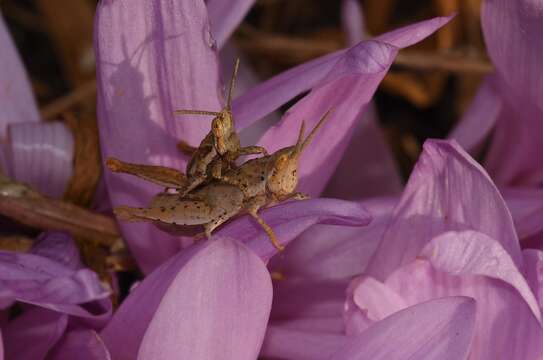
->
xmin=261 ymin=326 xmax=347 ymax=360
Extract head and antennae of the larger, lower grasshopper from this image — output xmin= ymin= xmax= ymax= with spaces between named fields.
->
xmin=267 ymin=110 xmax=330 ymax=197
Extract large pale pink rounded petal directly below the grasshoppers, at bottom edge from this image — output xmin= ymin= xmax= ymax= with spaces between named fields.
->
xmin=138 ymin=240 xmax=272 ymax=360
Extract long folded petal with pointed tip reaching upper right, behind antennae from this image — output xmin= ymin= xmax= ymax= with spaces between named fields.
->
xmin=259 ymin=18 xmax=450 ymax=195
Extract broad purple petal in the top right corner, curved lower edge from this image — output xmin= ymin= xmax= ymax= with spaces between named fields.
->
xmin=481 ymin=0 xmax=543 ymax=110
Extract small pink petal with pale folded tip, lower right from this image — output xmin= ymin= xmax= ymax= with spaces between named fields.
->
xmin=343 ymin=275 xmax=407 ymax=335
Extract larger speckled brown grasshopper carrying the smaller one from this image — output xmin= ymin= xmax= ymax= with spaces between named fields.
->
xmin=115 ymin=111 xmax=330 ymax=250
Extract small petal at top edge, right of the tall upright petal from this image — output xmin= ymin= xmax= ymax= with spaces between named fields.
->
xmin=207 ymin=0 xmax=255 ymax=48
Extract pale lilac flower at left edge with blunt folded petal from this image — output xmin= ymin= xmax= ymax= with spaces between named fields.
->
xmin=0 ymin=15 xmax=74 ymax=197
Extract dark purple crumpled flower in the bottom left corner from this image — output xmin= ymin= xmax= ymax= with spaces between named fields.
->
xmin=0 ymin=233 xmax=111 ymax=359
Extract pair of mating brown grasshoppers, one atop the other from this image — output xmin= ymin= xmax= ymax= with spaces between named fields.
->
xmin=108 ymin=62 xmax=329 ymax=250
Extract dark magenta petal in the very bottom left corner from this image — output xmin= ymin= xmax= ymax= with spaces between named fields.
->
xmin=2 ymin=307 xmax=68 ymax=360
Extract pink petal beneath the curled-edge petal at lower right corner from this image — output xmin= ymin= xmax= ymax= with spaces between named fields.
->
xmin=386 ymin=260 xmax=543 ymax=360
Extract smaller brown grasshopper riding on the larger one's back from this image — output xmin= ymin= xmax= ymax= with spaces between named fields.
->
xmin=107 ymin=59 xmax=267 ymax=196
